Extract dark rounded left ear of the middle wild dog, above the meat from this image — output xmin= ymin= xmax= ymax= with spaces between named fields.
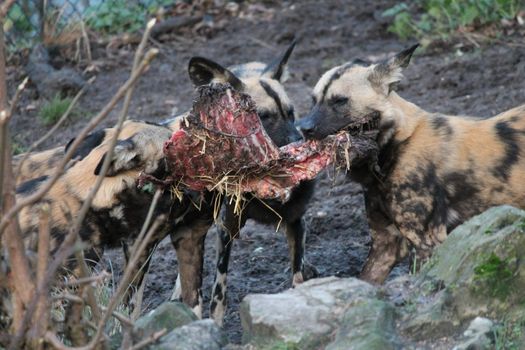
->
xmin=188 ymin=57 xmax=244 ymax=91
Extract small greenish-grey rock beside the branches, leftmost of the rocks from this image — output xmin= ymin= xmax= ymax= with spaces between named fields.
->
xmin=133 ymin=301 xmax=197 ymax=338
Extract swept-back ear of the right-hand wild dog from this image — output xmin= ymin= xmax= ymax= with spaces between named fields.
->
xmin=368 ymin=44 xmax=419 ymax=95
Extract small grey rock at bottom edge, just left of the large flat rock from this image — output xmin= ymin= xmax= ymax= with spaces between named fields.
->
xmin=150 ymin=319 xmax=228 ymax=350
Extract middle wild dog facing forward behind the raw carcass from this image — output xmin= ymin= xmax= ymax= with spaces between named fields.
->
xmin=172 ymin=43 xmax=315 ymax=324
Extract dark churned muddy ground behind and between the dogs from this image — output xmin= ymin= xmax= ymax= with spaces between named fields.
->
xmin=9 ymin=0 xmax=525 ymax=342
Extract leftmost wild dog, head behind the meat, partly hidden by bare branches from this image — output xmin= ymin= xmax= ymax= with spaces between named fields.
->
xmin=17 ymin=121 xmax=212 ymax=304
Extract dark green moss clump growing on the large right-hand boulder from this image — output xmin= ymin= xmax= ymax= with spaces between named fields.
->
xmin=474 ymin=253 xmax=513 ymax=299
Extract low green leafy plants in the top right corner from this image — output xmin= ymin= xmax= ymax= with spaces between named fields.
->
xmin=382 ymin=0 xmax=525 ymax=39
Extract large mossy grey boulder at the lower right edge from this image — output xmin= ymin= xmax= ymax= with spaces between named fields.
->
xmin=402 ymin=206 xmax=525 ymax=339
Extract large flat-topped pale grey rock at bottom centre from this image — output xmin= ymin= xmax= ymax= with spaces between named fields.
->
xmin=241 ymin=277 xmax=400 ymax=349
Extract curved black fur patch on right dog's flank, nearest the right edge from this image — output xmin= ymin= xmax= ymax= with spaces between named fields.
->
xmin=492 ymin=121 xmax=520 ymax=181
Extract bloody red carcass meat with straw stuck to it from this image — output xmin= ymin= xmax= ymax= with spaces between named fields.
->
xmin=164 ymin=84 xmax=376 ymax=200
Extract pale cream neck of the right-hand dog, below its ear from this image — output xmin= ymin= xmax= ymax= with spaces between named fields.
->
xmin=378 ymin=91 xmax=428 ymax=147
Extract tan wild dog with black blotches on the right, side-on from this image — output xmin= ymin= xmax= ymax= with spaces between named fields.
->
xmin=299 ymin=45 xmax=525 ymax=283
